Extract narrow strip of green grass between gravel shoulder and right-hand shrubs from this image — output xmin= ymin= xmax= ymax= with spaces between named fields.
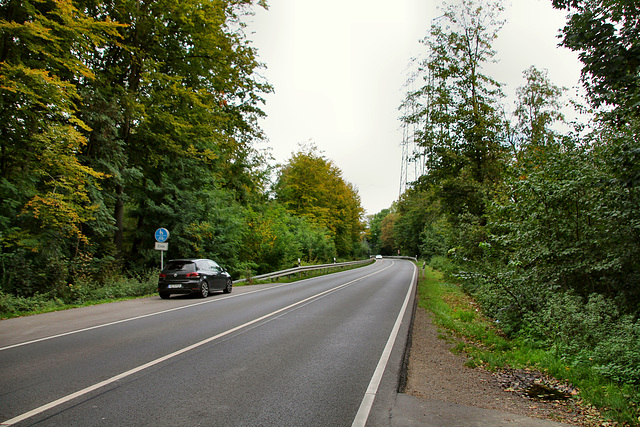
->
xmin=418 ymin=267 xmax=640 ymax=426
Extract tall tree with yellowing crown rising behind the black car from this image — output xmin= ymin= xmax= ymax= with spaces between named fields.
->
xmin=78 ymin=0 xmax=270 ymax=264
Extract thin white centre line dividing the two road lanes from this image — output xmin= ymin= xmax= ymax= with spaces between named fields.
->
xmin=0 ymin=263 xmax=393 ymax=426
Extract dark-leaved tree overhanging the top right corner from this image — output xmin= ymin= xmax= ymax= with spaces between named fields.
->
xmin=553 ymin=0 xmax=640 ymax=227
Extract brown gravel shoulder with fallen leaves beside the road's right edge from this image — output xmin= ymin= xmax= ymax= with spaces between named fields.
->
xmin=403 ymin=307 xmax=612 ymax=426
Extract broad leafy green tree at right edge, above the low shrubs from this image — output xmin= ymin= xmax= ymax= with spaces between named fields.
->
xmin=476 ymin=123 xmax=640 ymax=329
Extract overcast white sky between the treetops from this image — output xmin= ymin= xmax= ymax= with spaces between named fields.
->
xmin=247 ymin=0 xmax=581 ymax=214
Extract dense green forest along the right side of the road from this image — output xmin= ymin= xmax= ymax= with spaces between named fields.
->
xmin=369 ymin=0 xmax=640 ymax=385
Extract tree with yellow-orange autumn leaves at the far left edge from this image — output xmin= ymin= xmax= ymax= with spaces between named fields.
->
xmin=0 ymin=0 xmax=115 ymax=293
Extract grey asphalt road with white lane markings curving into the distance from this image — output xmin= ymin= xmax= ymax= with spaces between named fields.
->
xmin=0 ymin=260 xmax=417 ymax=426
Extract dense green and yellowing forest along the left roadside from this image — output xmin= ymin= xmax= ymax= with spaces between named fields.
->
xmin=0 ymin=0 xmax=364 ymax=298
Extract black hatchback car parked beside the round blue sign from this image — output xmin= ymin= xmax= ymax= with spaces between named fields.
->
xmin=158 ymin=259 xmax=233 ymax=299
